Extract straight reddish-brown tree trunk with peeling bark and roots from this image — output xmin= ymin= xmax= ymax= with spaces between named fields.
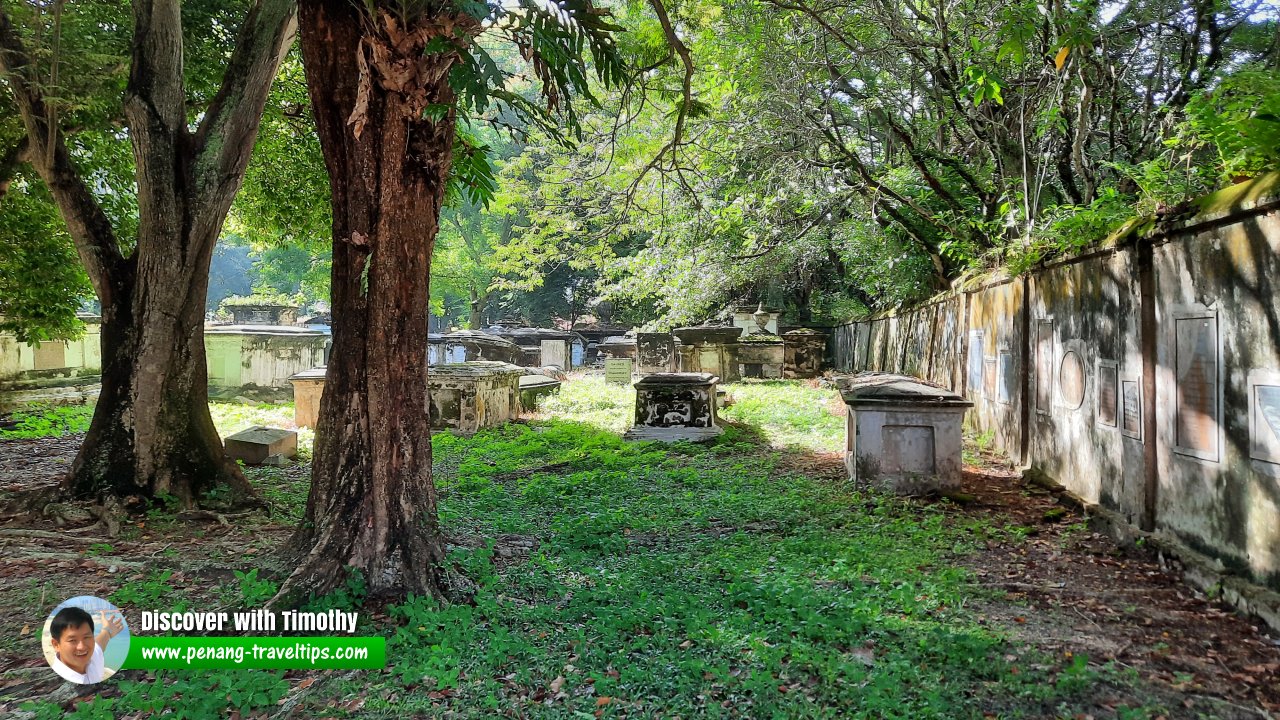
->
xmin=276 ymin=0 xmax=475 ymax=603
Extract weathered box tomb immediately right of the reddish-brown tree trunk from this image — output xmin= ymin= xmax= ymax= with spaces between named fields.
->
xmin=426 ymin=361 xmax=525 ymax=434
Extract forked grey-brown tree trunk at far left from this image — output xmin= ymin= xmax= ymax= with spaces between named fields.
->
xmin=0 ymin=0 xmax=294 ymax=506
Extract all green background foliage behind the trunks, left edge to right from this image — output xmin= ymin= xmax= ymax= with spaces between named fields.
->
xmin=12 ymin=0 xmax=1280 ymax=337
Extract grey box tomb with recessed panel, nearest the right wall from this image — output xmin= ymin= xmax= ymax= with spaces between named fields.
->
xmin=841 ymin=373 xmax=973 ymax=495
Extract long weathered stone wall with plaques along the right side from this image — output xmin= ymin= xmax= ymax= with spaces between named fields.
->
xmin=832 ymin=174 xmax=1280 ymax=604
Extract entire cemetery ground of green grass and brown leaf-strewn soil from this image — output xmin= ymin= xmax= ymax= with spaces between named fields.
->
xmin=0 ymin=377 xmax=1280 ymax=719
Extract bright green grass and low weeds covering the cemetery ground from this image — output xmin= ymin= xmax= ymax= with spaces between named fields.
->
xmin=12 ymin=379 xmax=1131 ymax=719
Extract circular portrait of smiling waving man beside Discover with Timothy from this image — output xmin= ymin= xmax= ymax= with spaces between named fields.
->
xmin=41 ymin=594 xmax=129 ymax=685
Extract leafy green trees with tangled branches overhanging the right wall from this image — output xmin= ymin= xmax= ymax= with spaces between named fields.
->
xmin=483 ymin=0 xmax=1280 ymax=322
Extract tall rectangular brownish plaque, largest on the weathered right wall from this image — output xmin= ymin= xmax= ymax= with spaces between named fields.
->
xmin=1174 ymin=316 xmax=1219 ymax=460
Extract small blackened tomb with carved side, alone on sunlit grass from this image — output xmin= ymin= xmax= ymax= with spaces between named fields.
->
xmin=623 ymin=373 xmax=724 ymax=442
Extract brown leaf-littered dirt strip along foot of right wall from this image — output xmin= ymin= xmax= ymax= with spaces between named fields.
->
xmin=961 ymin=456 xmax=1280 ymax=717
